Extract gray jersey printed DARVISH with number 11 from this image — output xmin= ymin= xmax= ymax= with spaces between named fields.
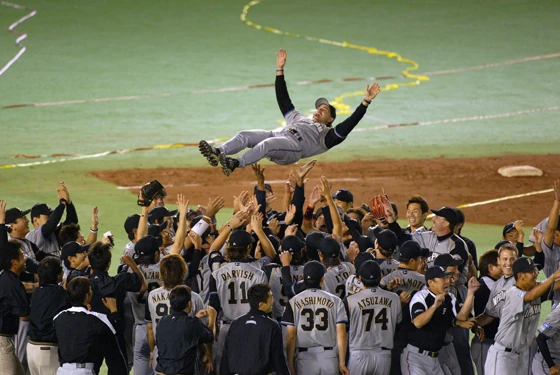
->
xmin=212 ymin=262 xmax=268 ymax=321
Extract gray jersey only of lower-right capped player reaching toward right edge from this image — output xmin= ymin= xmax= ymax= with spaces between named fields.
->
xmin=494 ymin=286 xmax=541 ymax=353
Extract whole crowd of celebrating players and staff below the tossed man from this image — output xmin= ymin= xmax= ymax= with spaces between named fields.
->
xmin=0 ymin=168 xmax=560 ymax=375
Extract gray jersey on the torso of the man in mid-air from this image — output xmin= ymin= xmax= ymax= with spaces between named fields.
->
xmin=280 ymin=109 xmax=330 ymax=158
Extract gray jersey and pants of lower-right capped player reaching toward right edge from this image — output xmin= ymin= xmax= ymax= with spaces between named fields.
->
xmin=484 ymin=286 xmax=541 ymax=375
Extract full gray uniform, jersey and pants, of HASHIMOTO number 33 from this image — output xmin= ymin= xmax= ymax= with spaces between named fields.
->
xmin=282 ymin=289 xmax=348 ymax=375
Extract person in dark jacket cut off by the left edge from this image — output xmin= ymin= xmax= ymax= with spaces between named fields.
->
xmin=0 ymin=241 xmax=29 ymax=375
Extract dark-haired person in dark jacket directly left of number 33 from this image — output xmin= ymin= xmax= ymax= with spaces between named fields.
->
xmin=220 ymin=284 xmax=290 ymax=375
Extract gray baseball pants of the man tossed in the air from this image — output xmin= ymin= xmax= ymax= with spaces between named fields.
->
xmin=219 ymin=130 xmax=303 ymax=168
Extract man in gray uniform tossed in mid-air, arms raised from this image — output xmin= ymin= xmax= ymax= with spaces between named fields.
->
xmin=198 ymin=49 xmax=380 ymax=176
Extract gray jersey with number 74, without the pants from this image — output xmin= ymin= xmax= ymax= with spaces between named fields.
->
xmin=348 ymin=288 xmax=402 ymax=350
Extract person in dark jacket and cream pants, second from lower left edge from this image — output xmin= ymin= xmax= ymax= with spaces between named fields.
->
xmin=27 ymin=257 xmax=70 ymax=375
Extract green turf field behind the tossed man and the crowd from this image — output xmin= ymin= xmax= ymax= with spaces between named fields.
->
xmin=0 ymin=0 xmax=560 ymax=374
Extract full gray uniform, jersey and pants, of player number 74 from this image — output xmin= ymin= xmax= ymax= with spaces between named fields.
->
xmin=347 ymin=288 xmax=402 ymax=375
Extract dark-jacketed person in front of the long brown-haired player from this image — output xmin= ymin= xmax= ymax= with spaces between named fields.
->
xmin=156 ymin=285 xmax=214 ymax=375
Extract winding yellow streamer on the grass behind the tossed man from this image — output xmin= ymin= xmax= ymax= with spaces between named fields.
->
xmin=239 ymin=0 xmax=430 ymax=115
